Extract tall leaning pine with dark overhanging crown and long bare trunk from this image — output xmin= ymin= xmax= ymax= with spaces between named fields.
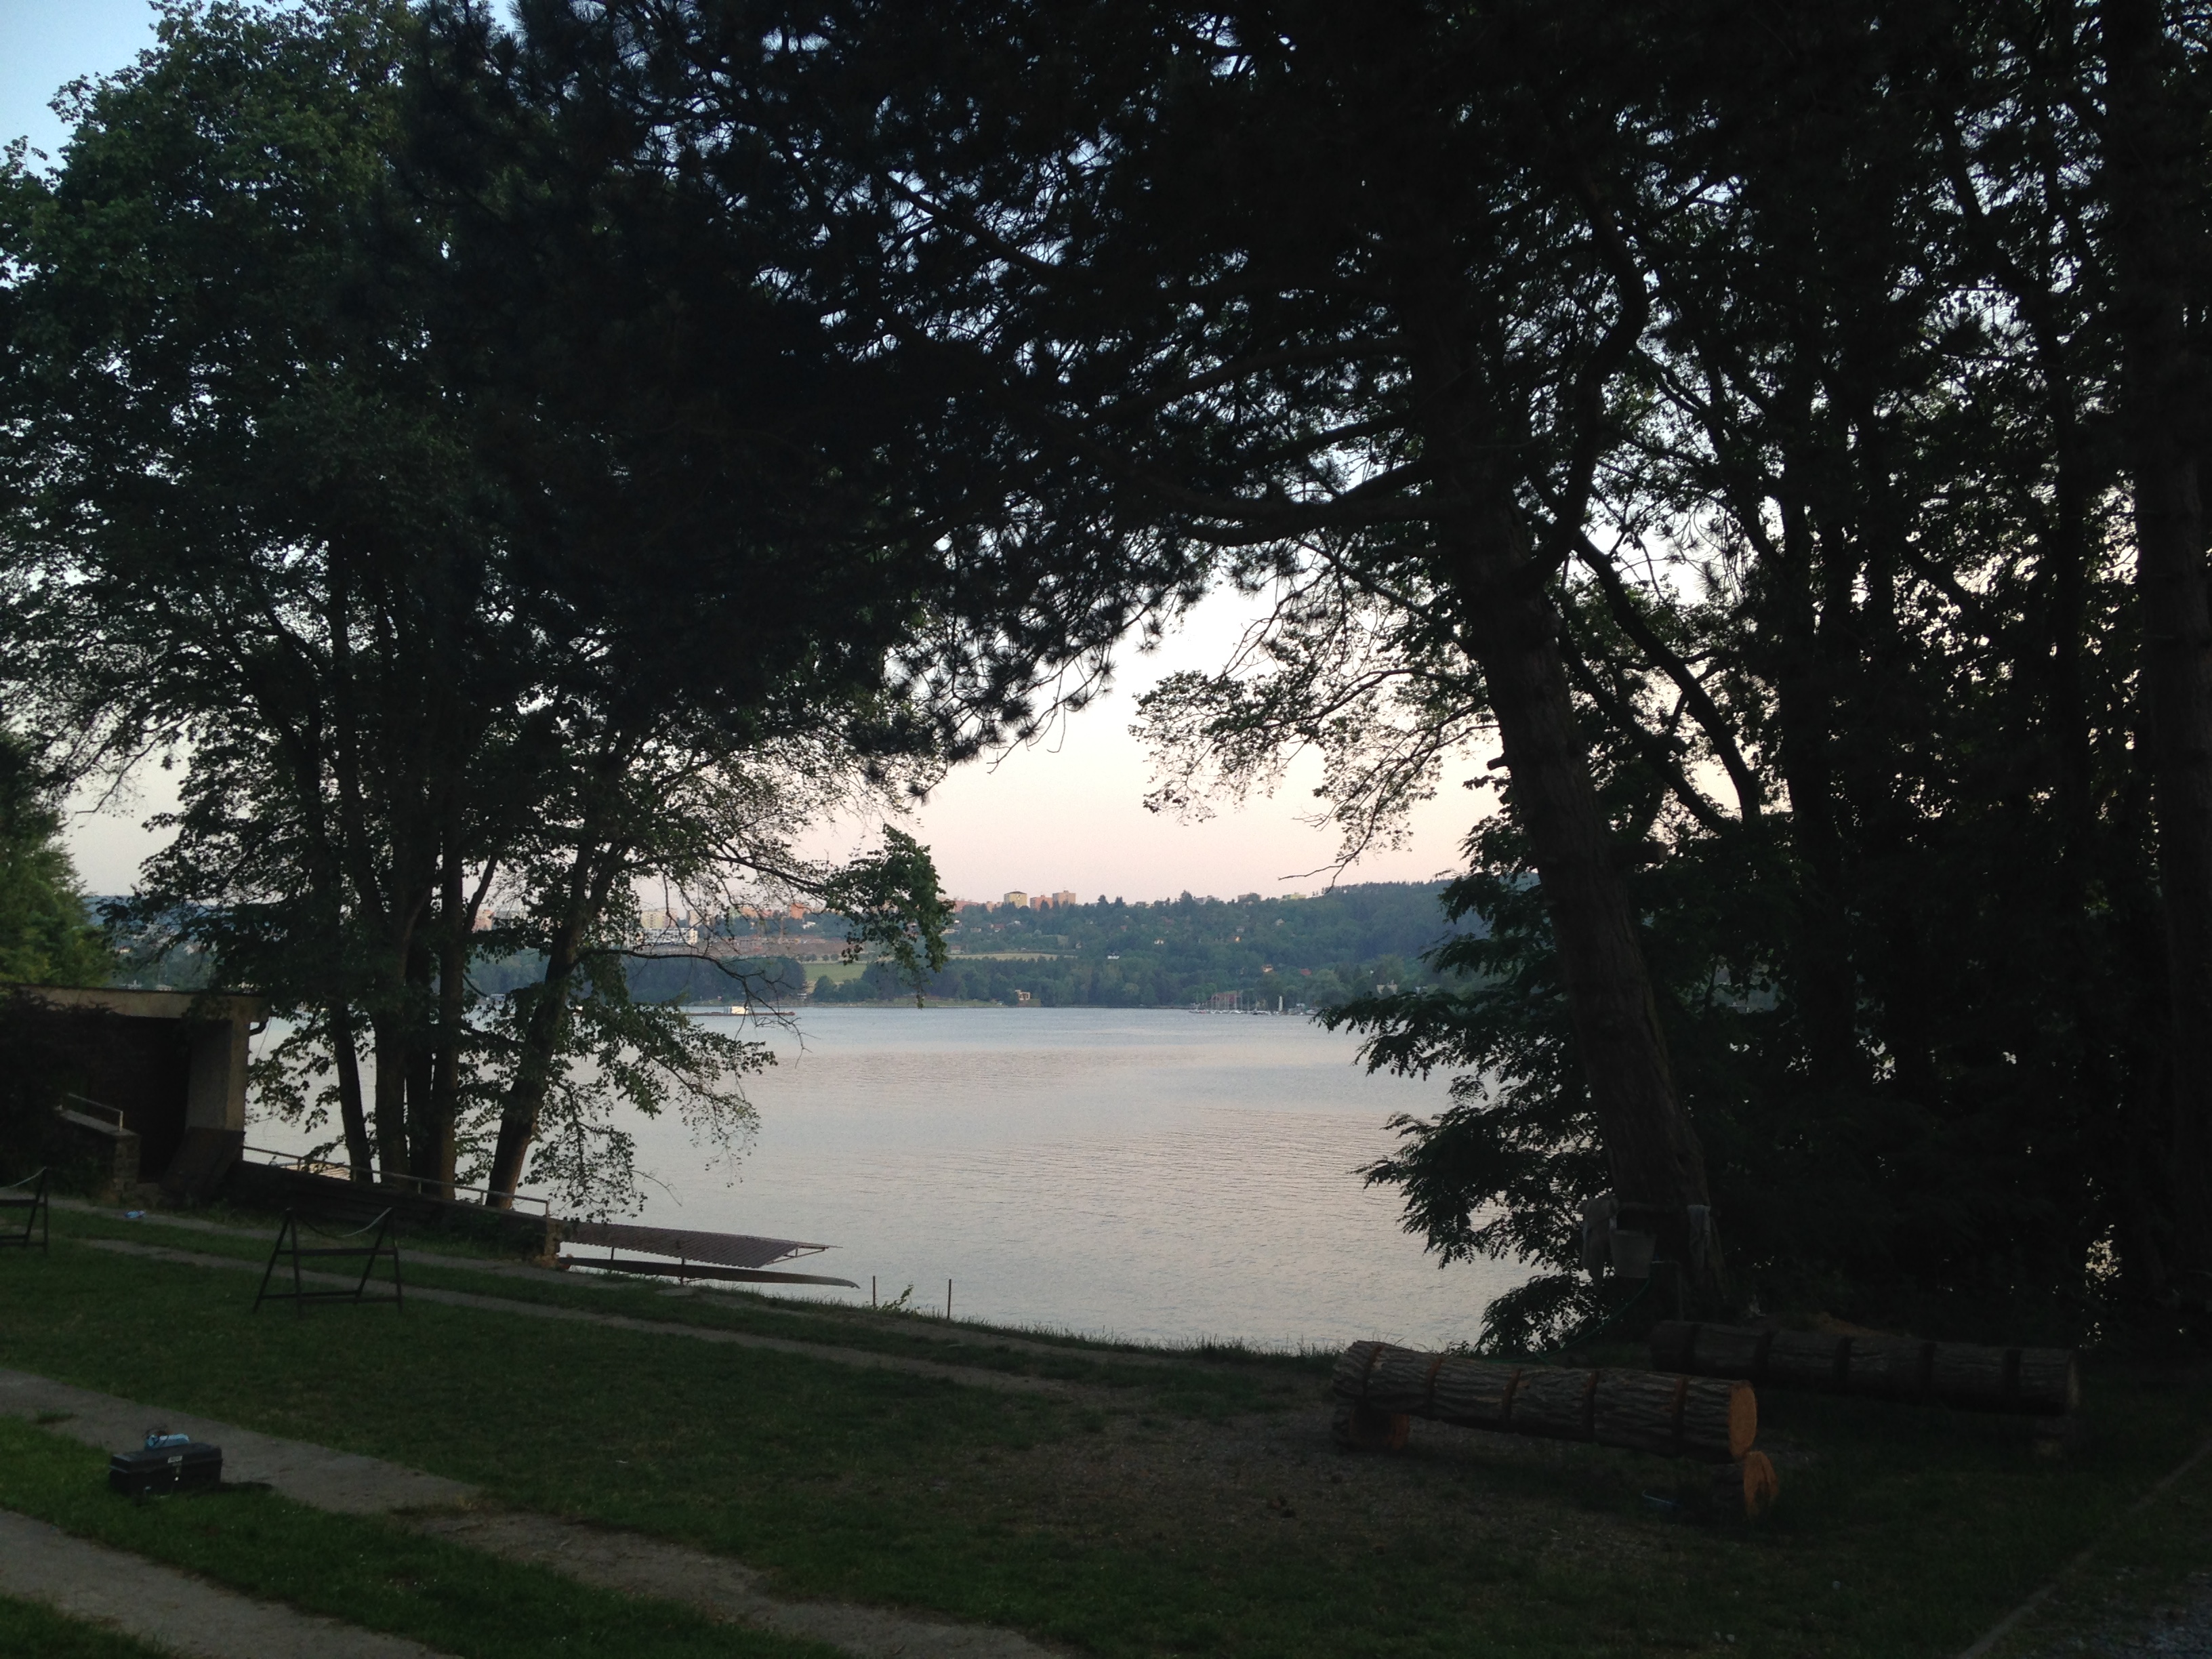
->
xmin=508 ymin=0 xmax=1719 ymax=1294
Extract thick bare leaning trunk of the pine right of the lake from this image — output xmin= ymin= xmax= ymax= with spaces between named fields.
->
xmin=1458 ymin=520 xmax=1721 ymax=1300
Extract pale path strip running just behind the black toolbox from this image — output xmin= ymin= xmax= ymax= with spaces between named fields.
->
xmin=0 ymin=1362 xmax=1053 ymax=1659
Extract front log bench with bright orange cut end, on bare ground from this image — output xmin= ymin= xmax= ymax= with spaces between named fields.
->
xmin=1332 ymin=1343 xmax=1763 ymax=1465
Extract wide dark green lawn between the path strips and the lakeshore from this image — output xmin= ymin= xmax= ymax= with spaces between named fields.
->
xmin=0 ymin=1212 xmax=2212 ymax=1659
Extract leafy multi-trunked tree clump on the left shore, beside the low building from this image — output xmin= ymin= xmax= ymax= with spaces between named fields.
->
xmin=0 ymin=0 xmax=960 ymax=1221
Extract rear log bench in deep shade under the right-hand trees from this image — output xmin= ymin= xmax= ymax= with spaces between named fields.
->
xmin=1652 ymin=1321 xmax=2081 ymax=1418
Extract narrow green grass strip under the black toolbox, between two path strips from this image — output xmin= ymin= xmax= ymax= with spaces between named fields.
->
xmin=0 ymin=1418 xmax=830 ymax=1659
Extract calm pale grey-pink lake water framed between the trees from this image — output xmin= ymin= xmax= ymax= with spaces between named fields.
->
xmin=252 ymin=1006 xmax=1519 ymax=1345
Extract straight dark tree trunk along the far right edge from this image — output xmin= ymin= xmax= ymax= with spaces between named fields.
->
xmin=2100 ymin=0 xmax=2212 ymax=1303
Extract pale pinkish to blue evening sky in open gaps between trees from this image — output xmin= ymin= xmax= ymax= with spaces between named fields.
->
xmin=0 ymin=0 xmax=1486 ymax=898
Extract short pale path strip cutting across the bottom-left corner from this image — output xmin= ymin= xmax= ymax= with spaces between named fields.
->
xmin=0 ymin=1509 xmax=451 ymax=1659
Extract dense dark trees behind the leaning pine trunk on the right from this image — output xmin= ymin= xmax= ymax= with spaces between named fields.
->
xmin=1309 ymin=7 xmax=2203 ymax=1345
